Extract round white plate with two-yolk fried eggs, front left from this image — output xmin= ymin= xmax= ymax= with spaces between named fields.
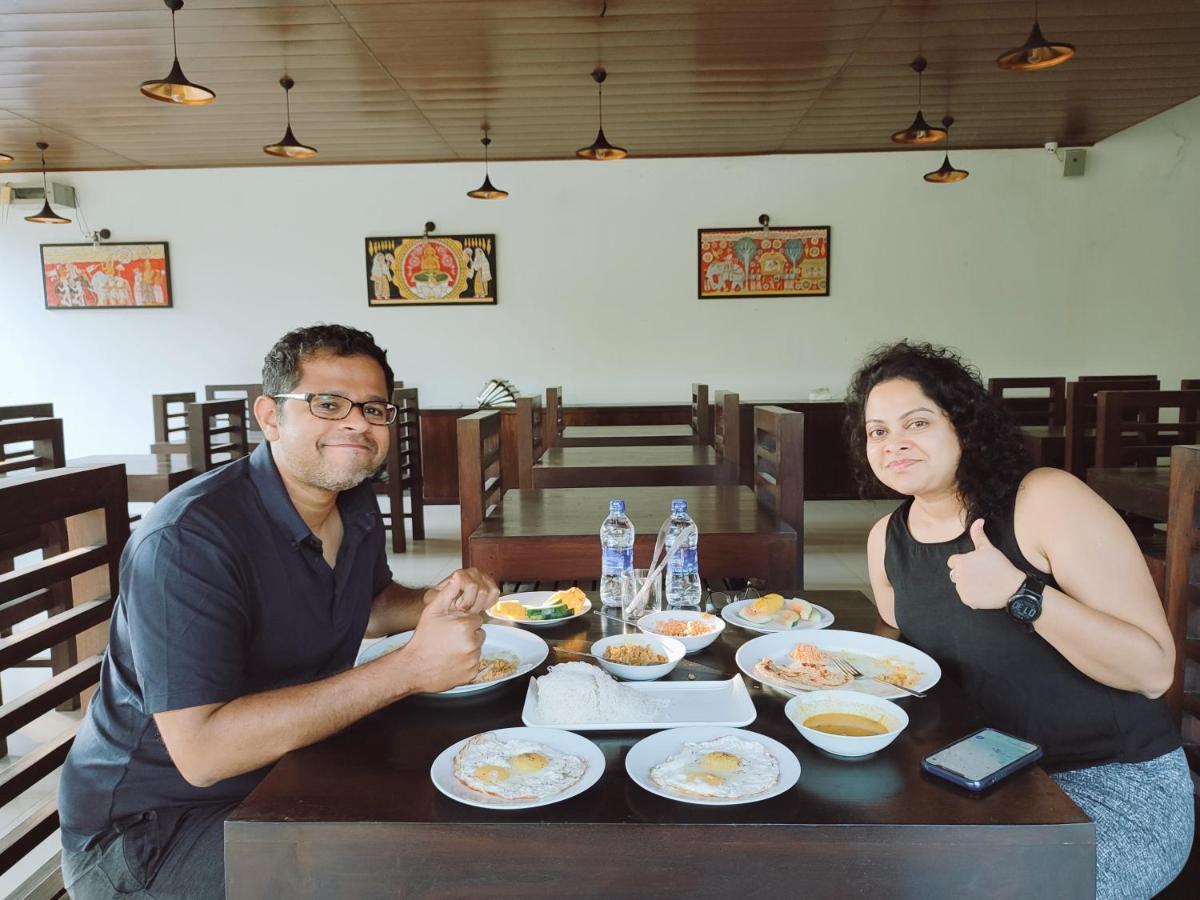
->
xmin=430 ymin=727 xmax=605 ymax=809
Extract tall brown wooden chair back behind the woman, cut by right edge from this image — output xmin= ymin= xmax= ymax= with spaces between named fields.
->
xmin=1163 ymin=445 xmax=1200 ymax=729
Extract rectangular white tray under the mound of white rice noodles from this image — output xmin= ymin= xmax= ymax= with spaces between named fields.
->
xmin=521 ymin=674 xmax=758 ymax=731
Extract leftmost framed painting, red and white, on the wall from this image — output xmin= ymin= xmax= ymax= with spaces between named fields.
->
xmin=42 ymin=241 xmax=172 ymax=310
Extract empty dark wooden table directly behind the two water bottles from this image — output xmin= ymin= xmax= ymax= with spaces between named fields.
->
xmin=467 ymin=485 xmax=802 ymax=584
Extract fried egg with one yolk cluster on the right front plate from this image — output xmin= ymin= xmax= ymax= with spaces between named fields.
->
xmin=650 ymin=734 xmax=779 ymax=800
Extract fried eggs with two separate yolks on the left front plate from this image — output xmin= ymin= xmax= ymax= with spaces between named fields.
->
xmin=454 ymin=731 xmax=588 ymax=800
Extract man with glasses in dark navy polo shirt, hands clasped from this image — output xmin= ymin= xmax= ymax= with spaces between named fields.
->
xmin=59 ymin=325 xmax=499 ymax=900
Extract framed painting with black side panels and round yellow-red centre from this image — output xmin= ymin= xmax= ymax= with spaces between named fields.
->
xmin=366 ymin=234 xmax=497 ymax=306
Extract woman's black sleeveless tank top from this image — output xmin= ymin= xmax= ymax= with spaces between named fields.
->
xmin=884 ymin=498 xmax=1180 ymax=772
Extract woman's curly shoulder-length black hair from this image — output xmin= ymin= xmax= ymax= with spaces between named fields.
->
xmin=845 ymin=340 xmax=1032 ymax=523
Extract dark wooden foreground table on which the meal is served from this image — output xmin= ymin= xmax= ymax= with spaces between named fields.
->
xmin=224 ymin=590 xmax=1096 ymax=900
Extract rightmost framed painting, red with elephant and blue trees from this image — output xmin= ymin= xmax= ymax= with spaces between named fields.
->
xmin=698 ymin=226 xmax=829 ymax=300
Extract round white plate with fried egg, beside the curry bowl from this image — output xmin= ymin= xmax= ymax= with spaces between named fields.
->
xmin=625 ymin=726 xmax=800 ymax=806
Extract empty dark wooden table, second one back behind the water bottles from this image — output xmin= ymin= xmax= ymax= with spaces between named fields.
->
xmin=533 ymin=445 xmax=725 ymax=487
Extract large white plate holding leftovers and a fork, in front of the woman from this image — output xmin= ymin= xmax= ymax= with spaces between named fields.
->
xmin=734 ymin=630 xmax=942 ymax=700
